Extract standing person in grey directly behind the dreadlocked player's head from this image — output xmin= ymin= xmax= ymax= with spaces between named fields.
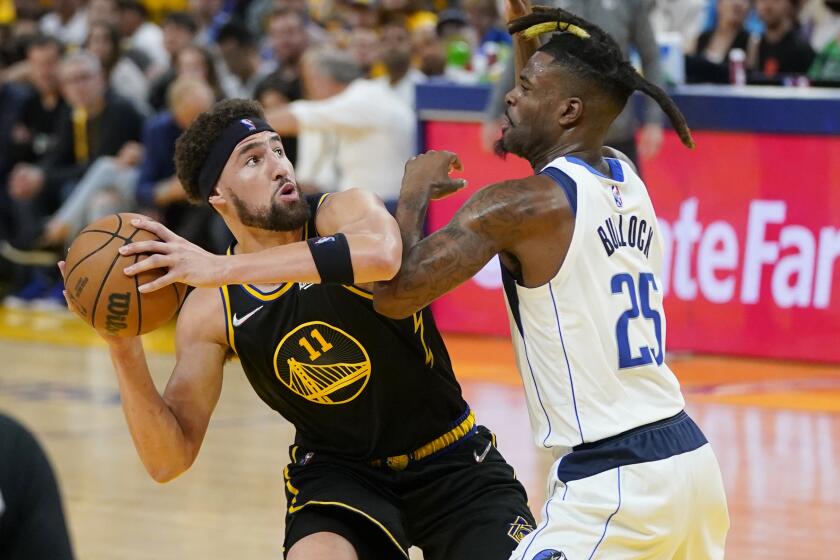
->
xmin=482 ymin=0 xmax=665 ymax=170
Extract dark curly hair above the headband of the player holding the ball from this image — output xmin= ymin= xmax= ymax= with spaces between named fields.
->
xmin=175 ymin=99 xmax=265 ymax=204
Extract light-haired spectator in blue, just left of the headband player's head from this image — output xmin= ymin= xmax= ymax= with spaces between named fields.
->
xmin=136 ymin=78 xmax=224 ymax=250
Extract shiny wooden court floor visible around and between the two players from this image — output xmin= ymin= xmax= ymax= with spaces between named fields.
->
xmin=0 ymin=309 xmax=840 ymax=560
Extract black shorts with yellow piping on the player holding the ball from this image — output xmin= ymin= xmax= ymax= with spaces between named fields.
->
xmin=284 ymin=426 xmax=535 ymax=560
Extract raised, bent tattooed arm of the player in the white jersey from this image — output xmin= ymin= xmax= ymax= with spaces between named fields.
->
xmin=373 ymin=152 xmax=569 ymax=318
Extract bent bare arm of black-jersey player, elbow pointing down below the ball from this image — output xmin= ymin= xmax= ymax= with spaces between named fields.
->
xmin=108 ymin=290 xmax=227 ymax=482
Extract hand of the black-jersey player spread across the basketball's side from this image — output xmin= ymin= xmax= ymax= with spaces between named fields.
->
xmin=120 ymin=218 xmax=222 ymax=293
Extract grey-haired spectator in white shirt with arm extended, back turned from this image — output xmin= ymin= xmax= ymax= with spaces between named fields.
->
xmin=266 ymin=48 xmax=416 ymax=210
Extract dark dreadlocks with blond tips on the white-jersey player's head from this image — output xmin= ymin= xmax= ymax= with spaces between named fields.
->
xmin=508 ymin=6 xmax=694 ymax=148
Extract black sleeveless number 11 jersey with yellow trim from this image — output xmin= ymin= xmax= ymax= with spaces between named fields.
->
xmin=220 ymin=196 xmax=467 ymax=460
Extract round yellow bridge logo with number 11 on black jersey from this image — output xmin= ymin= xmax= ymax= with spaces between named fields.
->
xmin=274 ymin=321 xmax=370 ymax=404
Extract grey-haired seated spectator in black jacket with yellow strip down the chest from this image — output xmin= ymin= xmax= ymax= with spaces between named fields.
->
xmin=9 ymin=52 xmax=143 ymax=253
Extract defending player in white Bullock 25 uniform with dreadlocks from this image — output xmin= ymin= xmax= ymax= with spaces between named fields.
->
xmin=374 ymin=4 xmax=729 ymax=560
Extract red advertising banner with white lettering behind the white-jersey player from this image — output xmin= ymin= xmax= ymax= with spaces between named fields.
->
xmin=426 ymin=122 xmax=840 ymax=362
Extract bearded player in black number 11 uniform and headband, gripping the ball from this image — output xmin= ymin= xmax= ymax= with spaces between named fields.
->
xmin=59 ymin=100 xmax=533 ymax=560
